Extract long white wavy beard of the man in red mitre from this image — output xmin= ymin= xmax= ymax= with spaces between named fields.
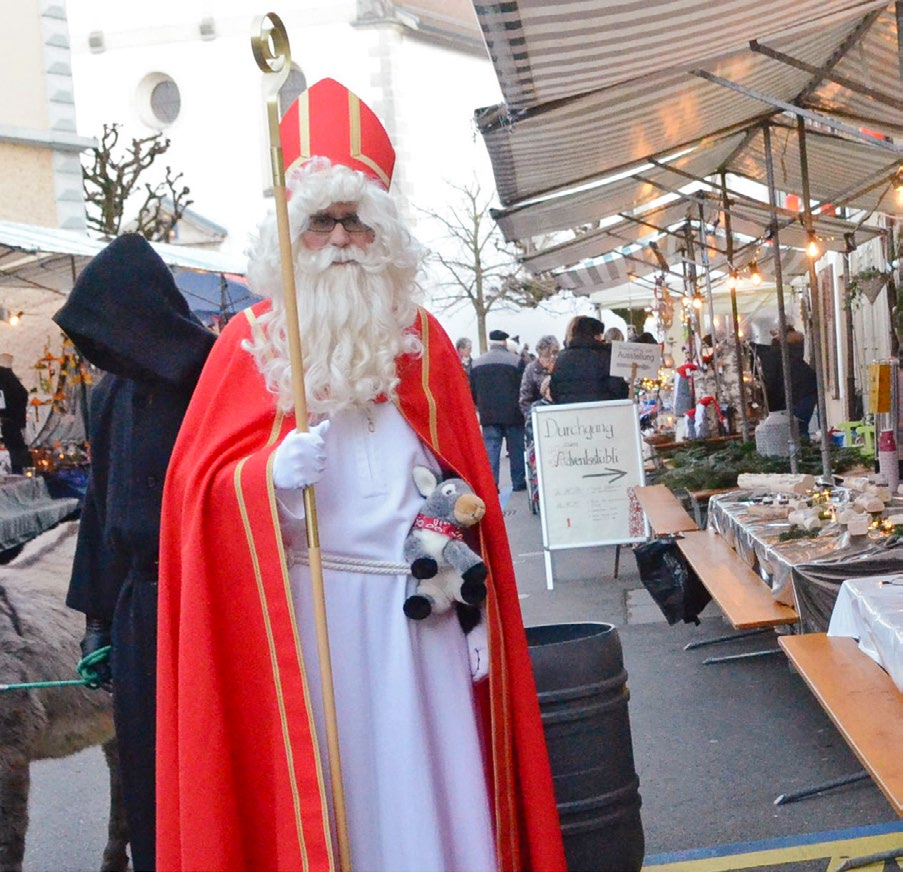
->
xmin=250 ymin=246 xmax=422 ymax=417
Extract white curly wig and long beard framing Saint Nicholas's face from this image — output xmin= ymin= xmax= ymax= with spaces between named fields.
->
xmin=244 ymin=158 xmax=423 ymax=417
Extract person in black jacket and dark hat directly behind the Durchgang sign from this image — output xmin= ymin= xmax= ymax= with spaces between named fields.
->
xmin=549 ymin=315 xmax=630 ymax=403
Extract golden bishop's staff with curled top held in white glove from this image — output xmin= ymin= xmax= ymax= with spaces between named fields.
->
xmin=251 ymin=12 xmax=351 ymax=872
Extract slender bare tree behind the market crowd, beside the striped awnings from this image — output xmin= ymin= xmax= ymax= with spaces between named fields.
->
xmin=421 ymin=181 xmax=557 ymax=351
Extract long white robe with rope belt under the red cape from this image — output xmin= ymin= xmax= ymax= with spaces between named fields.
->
xmin=282 ymin=403 xmax=497 ymax=872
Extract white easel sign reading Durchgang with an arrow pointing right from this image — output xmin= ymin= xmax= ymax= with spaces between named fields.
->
xmin=533 ymin=400 xmax=647 ymax=590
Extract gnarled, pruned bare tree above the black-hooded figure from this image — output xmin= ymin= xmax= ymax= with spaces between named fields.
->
xmin=82 ymin=124 xmax=193 ymax=242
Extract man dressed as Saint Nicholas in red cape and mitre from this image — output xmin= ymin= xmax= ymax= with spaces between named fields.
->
xmin=157 ymin=79 xmax=565 ymax=872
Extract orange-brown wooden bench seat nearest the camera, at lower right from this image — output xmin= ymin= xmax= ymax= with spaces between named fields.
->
xmin=778 ymin=633 xmax=903 ymax=817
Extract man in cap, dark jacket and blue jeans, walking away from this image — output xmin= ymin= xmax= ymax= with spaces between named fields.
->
xmin=470 ymin=330 xmax=527 ymax=491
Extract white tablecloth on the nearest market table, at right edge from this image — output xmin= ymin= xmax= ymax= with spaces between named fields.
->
xmin=828 ymin=575 xmax=903 ymax=693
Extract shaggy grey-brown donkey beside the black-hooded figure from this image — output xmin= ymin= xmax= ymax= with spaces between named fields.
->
xmin=0 ymin=522 xmax=128 ymax=872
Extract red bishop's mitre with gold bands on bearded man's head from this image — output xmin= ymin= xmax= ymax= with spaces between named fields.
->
xmin=279 ymin=79 xmax=395 ymax=190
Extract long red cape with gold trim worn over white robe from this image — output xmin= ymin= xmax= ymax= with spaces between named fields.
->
xmin=157 ymin=303 xmax=566 ymax=872
